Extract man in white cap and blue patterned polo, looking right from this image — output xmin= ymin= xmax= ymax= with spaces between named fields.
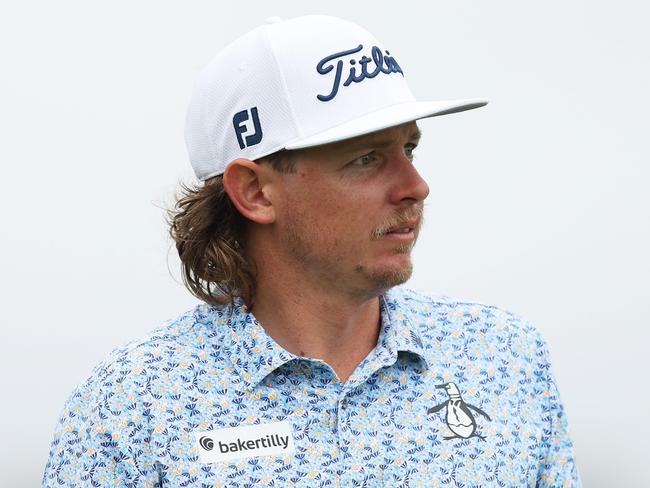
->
xmin=44 ymin=16 xmax=578 ymax=487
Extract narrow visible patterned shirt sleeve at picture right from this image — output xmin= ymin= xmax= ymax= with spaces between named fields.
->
xmin=537 ymin=336 xmax=582 ymax=488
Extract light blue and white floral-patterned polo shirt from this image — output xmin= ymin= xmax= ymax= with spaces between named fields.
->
xmin=43 ymin=287 xmax=579 ymax=488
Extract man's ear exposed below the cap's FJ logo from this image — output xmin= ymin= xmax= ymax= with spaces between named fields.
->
xmin=223 ymin=158 xmax=275 ymax=224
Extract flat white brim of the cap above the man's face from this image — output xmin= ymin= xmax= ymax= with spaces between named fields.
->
xmin=285 ymin=98 xmax=488 ymax=149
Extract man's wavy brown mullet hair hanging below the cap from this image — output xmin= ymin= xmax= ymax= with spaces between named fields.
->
xmin=167 ymin=149 xmax=295 ymax=309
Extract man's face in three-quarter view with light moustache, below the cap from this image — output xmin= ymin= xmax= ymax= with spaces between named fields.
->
xmin=274 ymin=122 xmax=429 ymax=298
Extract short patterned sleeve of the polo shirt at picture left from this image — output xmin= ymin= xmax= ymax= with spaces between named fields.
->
xmin=43 ymin=370 xmax=159 ymax=487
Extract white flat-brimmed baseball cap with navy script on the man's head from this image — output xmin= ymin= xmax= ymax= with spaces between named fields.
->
xmin=185 ymin=15 xmax=487 ymax=180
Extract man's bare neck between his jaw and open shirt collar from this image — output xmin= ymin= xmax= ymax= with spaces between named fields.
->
xmin=248 ymin=255 xmax=380 ymax=382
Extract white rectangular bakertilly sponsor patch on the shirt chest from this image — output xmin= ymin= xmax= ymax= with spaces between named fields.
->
xmin=196 ymin=422 xmax=294 ymax=463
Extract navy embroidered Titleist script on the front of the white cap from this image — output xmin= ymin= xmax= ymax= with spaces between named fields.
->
xmin=316 ymin=44 xmax=404 ymax=102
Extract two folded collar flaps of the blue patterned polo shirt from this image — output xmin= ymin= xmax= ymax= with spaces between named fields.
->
xmin=223 ymin=289 xmax=428 ymax=389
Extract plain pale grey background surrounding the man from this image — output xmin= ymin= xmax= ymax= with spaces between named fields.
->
xmin=0 ymin=0 xmax=650 ymax=487
